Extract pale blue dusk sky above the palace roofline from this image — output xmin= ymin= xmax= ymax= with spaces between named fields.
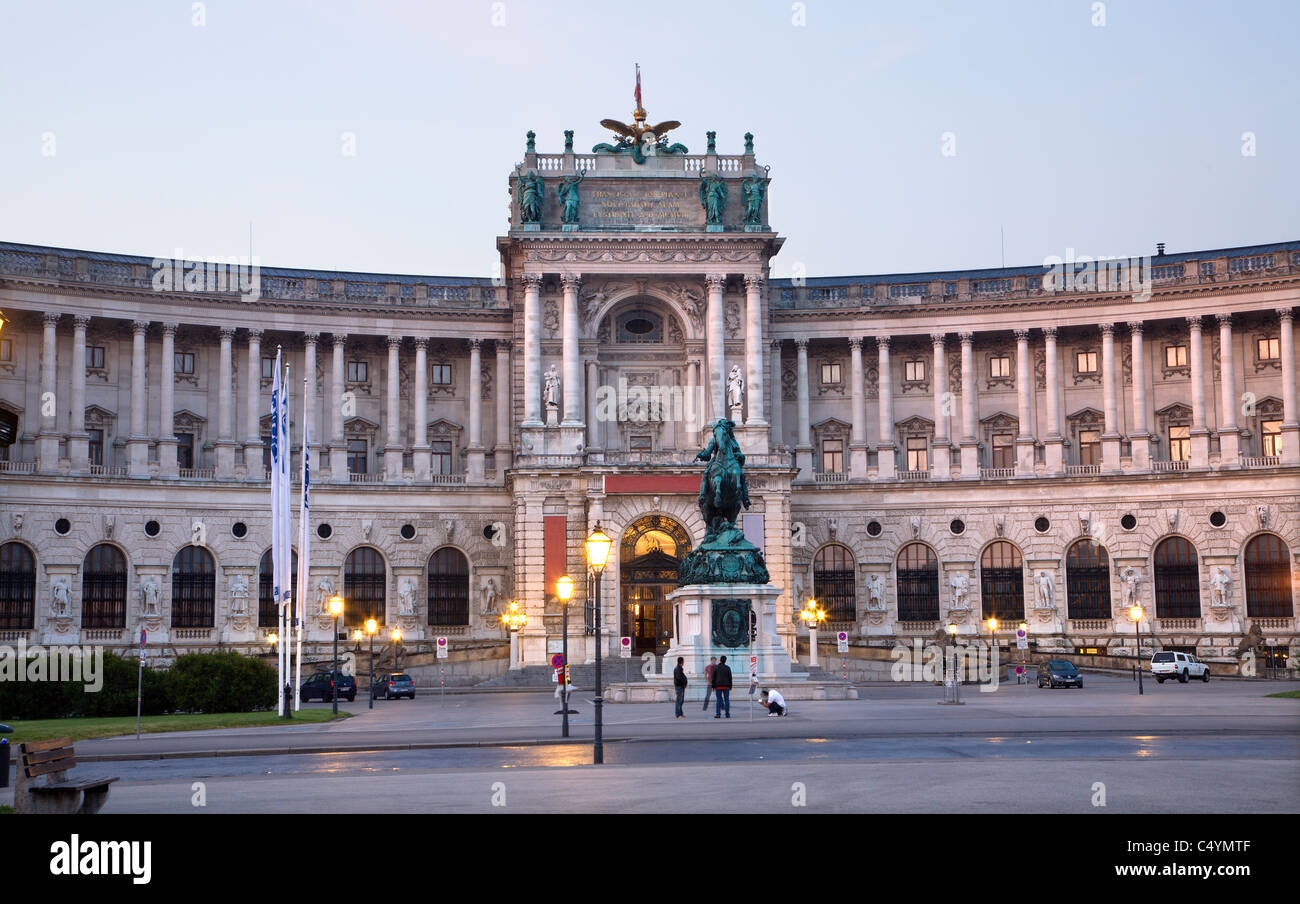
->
xmin=0 ymin=0 xmax=1300 ymax=276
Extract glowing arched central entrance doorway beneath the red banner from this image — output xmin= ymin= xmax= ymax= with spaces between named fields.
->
xmin=619 ymin=515 xmax=690 ymax=656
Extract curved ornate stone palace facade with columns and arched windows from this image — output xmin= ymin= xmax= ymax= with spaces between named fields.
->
xmin=0 ymin=128 xmax=1300 ymax=665
